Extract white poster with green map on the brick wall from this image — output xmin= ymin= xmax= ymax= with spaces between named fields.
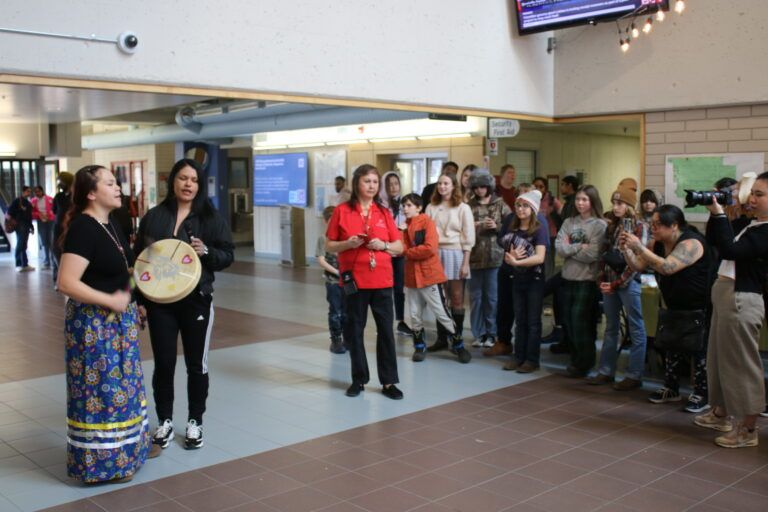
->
xmin=664 ymin=153 xmax=765 ymax=222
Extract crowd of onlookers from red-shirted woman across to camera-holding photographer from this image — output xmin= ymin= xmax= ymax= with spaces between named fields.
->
xmin=317 ymin=162 xmax=768 ymax=447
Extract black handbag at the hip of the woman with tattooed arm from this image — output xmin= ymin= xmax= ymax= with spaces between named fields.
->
xmin=653 ymin=309 xmax=707 ymax=352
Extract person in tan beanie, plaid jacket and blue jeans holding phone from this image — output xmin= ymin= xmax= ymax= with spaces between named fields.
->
xmin=587 ymin=188 xmax=648 ymax=391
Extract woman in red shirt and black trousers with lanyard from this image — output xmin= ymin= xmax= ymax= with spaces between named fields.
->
xmin=325 ymin=164 xmax=403 ymax=400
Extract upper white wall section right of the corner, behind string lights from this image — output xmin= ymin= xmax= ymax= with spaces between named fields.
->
xmin=554 ymin=0 xmax=768 ymax=116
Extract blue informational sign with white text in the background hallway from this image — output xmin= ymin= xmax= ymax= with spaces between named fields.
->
xmin=253 ymin=153 xmax=308 ymax=207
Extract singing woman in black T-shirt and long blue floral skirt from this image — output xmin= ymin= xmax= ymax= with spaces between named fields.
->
xmin=59 ymin=166 xmax=160 ymax=483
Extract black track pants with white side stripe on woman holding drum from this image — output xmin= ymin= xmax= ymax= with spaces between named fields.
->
xmin=147 ymin=291 xmax=214 ymax=424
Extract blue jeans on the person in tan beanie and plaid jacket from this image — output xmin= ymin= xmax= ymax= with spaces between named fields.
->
xmin=598 ymin=279 xmax=646 ymax=380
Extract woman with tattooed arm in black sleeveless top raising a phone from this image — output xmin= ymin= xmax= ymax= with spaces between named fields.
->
xmin=620 ymin=204 xmax=714 ymax=412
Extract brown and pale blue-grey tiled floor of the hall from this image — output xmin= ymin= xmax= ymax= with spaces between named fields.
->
xmin=0 ymin=246 xmax=768 ymax=512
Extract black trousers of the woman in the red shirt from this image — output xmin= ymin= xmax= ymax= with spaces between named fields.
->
xmin=344 ymin=288 xmax=400 ymax=385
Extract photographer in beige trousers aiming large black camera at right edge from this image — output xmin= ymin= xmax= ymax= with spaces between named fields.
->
xmin=694 ymin=172 xmax=768 ymax=448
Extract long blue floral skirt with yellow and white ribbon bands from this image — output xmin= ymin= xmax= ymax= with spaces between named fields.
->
xmin=64 ymin=300 xmax=150 ymax=483
